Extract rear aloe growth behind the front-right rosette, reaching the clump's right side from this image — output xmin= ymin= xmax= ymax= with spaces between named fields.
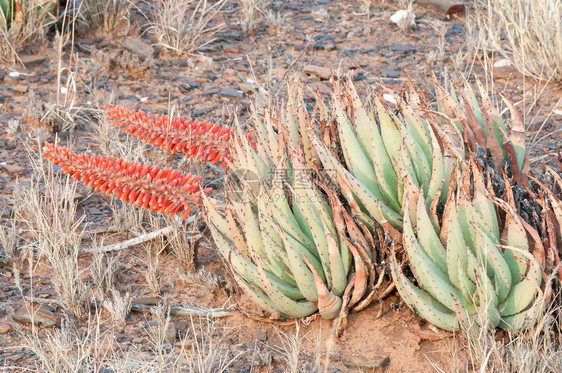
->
xmin=313 ymin=77 xmax=528 ymax=240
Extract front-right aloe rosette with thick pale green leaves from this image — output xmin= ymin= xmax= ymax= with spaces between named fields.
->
xmin=391 ymin=163 xmax=544 ymax=331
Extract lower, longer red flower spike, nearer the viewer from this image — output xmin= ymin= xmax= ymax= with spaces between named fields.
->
xmin=43 ymin=143 xmax=211 ymax=220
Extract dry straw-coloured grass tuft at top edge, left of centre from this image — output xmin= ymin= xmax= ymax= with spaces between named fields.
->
xmin=150 ymin=0 xmax=226 ymax=54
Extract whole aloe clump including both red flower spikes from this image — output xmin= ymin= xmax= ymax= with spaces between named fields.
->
xmin=44 ymin=77 xmax=552 ymax=330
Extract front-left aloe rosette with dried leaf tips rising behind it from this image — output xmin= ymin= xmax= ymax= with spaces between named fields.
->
xmin=203 ymin=83 xmax=374 ymax=319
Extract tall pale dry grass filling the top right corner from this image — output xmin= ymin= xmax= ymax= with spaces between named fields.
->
xmin=467 ymin=0 xmax=562 ymax=82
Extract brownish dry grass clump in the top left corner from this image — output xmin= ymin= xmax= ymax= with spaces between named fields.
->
xmin=0 ymin=0 xmax=56 ymax=63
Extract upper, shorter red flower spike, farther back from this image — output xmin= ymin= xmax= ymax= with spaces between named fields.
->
xmin=106 ymin=105 xmax=234 ymax=168
